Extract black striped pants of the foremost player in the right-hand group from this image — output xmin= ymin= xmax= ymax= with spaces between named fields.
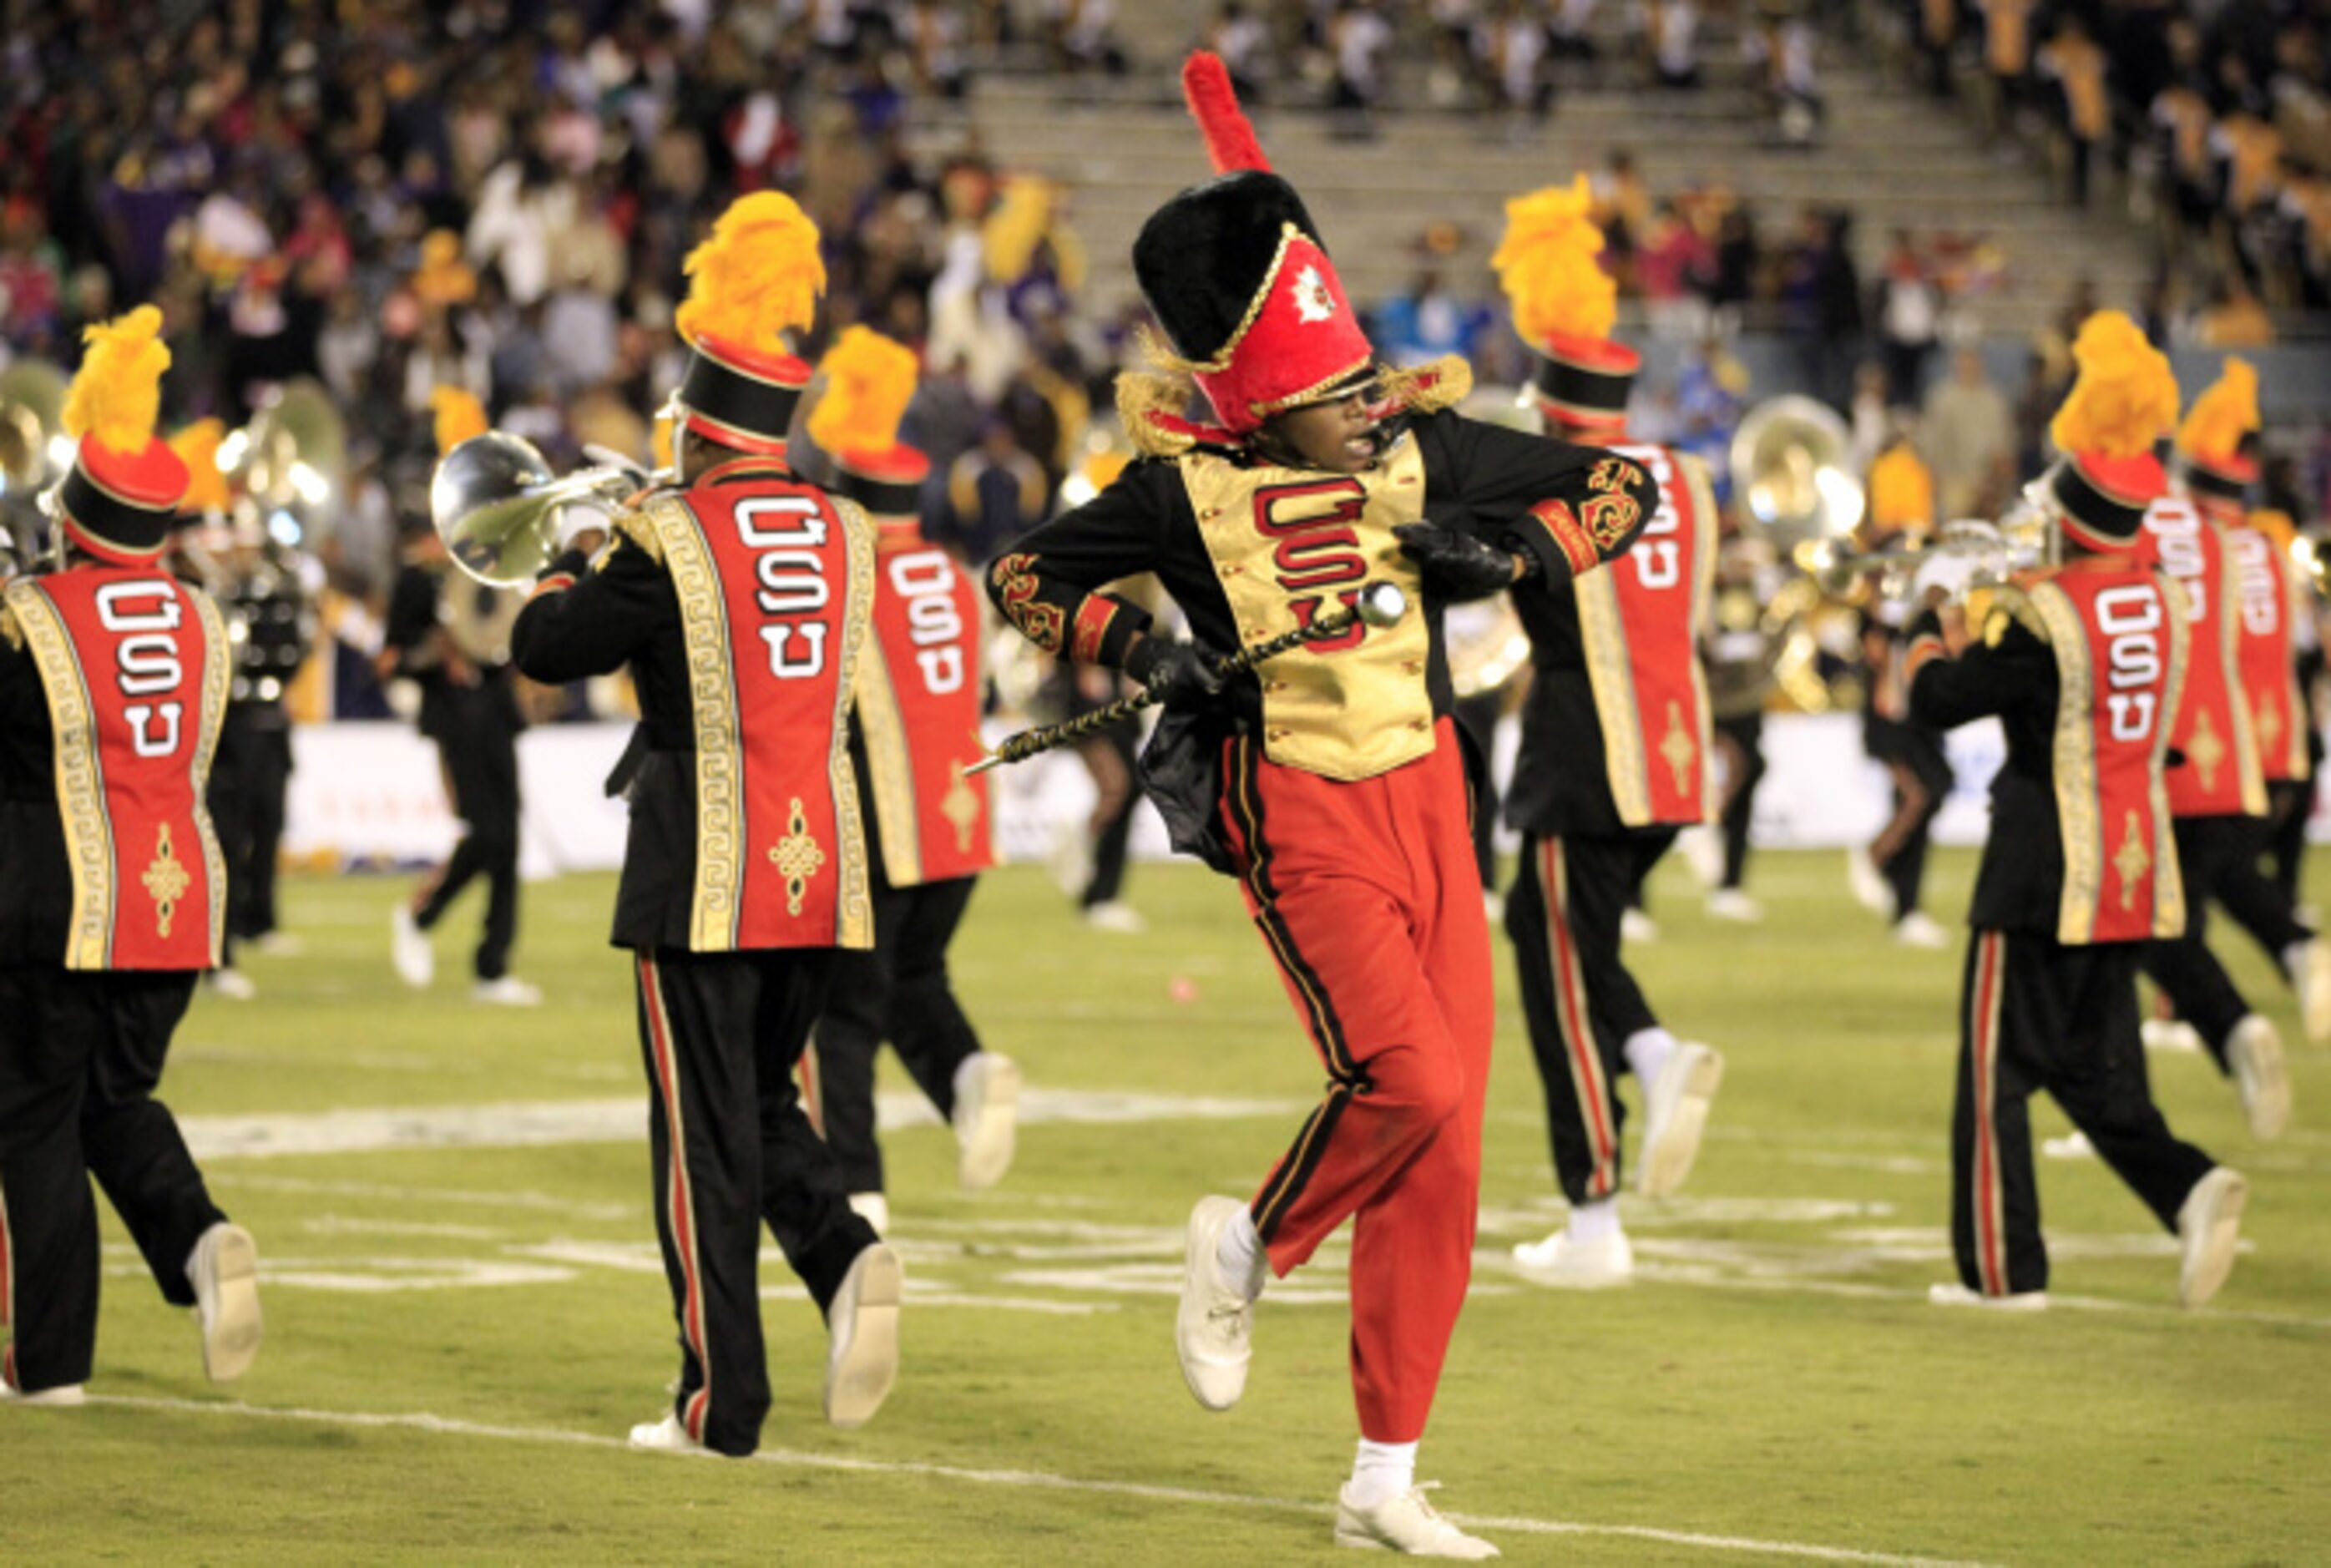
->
xmin=1951 ymin=929 xmax=2212 ymax=1296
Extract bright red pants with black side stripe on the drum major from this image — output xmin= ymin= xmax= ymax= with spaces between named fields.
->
xmin=1224 ymin=720 xmax=1494 ymax=1442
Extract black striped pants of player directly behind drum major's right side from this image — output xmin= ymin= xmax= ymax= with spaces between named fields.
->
xmin=1506 ymin=827 xmax=1676 ymax=1205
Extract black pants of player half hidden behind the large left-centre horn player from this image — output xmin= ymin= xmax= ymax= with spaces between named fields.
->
xmin=812 ymin=876 xmax=979 ymax=1193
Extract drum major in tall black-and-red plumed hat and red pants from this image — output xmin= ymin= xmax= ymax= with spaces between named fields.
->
xmin=989 ymin=53 xmax=1655 ymax=1559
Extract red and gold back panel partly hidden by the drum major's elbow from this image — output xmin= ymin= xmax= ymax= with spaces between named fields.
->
xmin=1571 ymin=448 xmax=1716 ymax=827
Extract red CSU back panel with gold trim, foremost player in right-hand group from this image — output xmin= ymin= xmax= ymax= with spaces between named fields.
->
xmin=2030 ymin=557 xmax=2187 ymax=943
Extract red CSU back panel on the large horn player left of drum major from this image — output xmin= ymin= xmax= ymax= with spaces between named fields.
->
xmin=641 ymin=463 xmax=874 ymax=953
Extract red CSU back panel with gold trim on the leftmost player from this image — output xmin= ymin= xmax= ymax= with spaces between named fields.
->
xmin=7 ymin=566 xmax=229 ymax=969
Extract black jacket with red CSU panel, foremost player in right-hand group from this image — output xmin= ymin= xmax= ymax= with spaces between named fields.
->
xmin=1909 ymin=554 xmax=2189 ymax=946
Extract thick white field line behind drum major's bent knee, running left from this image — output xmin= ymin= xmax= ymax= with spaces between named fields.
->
xmin=180 ymin=1088 xmax=1307 ymax=1161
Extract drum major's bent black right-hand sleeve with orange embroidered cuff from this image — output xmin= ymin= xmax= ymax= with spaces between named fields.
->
xmin=1418 ymin=412 xmax=1660 ymax=592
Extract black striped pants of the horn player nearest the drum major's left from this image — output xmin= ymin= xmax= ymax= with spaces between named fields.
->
xmin=636 ymin=948 xmax=874 ymax=1456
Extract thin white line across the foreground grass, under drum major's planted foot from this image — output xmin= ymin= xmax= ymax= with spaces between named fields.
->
xmin=88 ymin=1393 xmax=1984 ymax=1568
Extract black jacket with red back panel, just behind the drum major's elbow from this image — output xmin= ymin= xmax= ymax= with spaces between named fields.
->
xmin=1506 ymin=433 xmax=1716 ymax=837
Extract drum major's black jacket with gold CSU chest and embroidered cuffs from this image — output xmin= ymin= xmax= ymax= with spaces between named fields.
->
xmin=989 ymin=412 xmax=1657 ymax=864
